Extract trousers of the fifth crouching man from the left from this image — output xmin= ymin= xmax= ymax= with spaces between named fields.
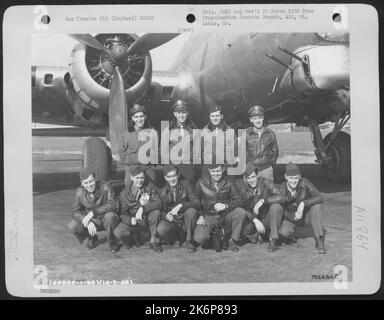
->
xmin=244 ymin=203 xmax=284 ymax=242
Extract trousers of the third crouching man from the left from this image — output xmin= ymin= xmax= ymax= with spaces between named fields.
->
xmin=157 ymin=208 xmax=198 ymax=241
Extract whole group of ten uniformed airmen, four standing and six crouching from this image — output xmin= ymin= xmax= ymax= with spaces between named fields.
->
xmin=68 ymin=100 xmax=326 ymax=253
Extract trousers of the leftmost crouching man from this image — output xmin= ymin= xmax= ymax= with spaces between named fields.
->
xmin=68 ymin=212 xmax=119 ymax=245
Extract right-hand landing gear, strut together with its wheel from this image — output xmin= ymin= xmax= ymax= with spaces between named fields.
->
xmin=308 ymin=112 xmax=351 ymax=182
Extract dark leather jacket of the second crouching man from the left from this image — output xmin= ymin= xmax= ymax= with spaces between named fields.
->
xmin=119 ymin=181 xmax=162 ymax=223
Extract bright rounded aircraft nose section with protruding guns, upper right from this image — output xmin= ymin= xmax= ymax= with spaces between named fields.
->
xmin=277 ymin=45 xmax=349 ymax=95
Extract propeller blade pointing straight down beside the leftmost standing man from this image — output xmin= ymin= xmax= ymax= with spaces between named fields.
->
xmin=109 ymin=66 xmax=128 ymax=160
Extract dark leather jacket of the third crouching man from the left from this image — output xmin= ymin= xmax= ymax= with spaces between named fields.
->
xmin=159 ymin=180 xmax=201 ymax=219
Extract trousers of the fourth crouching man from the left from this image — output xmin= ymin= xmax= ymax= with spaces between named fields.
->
xmin=193 ymin=207 xmax=247 ymax=244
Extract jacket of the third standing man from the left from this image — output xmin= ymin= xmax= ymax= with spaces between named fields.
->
xmin=201 ymin=120 xmax=237 ymax=163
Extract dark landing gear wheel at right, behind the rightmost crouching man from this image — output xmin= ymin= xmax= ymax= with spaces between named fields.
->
xmin=324 ymin=131 xmax=351 ymax=182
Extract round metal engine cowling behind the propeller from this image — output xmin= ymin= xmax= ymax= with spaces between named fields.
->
xmin=69 ymin=34 xmax=152 ymax=113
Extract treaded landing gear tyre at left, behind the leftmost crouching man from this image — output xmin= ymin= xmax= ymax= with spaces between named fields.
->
xmin=83 ymin=137 xmax=111 ymax=181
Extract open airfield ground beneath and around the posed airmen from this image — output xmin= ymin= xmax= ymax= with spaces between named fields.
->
xmin=33 ymin=132 xmax=352 ymax=283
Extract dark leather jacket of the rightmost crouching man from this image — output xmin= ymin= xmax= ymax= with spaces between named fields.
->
xmin=280 ymin=178 xmax=323 ymax=221
